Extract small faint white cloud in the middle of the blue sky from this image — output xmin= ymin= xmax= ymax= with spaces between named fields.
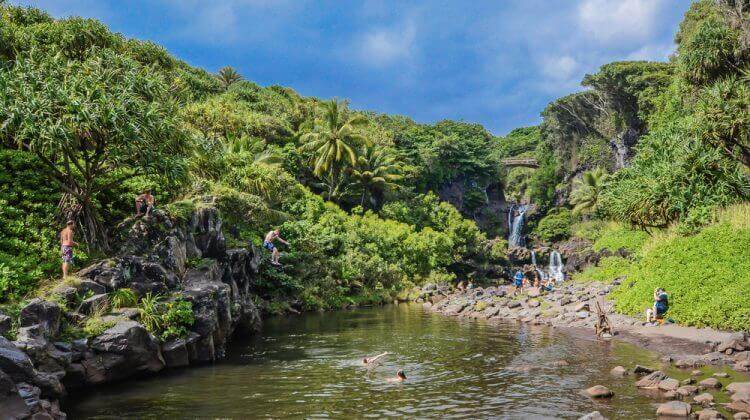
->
xmin=358 ymin=21 xmax=417 ymax=66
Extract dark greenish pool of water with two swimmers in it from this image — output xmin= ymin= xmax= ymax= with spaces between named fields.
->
xmin=64 ymin=305 xmax=680 ymax=419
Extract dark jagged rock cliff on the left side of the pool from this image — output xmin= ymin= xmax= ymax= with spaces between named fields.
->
xmin=0 ymin=198 xmax=260 ymax=418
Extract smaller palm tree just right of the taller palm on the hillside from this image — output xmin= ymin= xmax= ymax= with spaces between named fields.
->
xmin=351 ymin=148 xmax=403 ymax=208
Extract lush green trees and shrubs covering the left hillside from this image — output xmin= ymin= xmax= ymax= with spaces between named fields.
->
xmin=0 ymin=5 xmax=505 ymax=312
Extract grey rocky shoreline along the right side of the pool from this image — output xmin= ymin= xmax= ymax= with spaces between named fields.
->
xmin=424 ymin=280 xmax=750 ymax=420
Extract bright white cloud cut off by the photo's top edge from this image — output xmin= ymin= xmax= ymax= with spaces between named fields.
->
xmin=578 ymin=0 xmax=664 ymax=43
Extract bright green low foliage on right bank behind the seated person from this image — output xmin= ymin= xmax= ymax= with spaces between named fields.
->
xmin=612 ymin=222 xmax=750 ymax=330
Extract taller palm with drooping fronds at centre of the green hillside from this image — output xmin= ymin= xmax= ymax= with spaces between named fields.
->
xmin=300 ymin=99 xmax=368 ymax=199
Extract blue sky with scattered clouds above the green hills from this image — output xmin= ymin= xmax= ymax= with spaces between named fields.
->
xmin=12 ymin=0 xmax=690 ymax=134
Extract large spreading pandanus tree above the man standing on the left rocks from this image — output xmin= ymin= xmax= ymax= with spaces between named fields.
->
xmin=0 ymin=50 xmax=187 ymax=249
